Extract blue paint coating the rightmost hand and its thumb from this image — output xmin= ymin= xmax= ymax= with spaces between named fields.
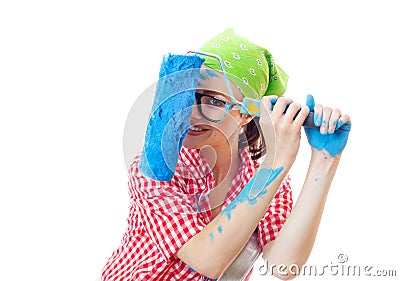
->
xmin=304 ymin=95 xmax=351 ymax=157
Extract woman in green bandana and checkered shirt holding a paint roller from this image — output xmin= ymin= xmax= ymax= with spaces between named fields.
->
xmin=102 ymin=29 xmax=350 ymax=280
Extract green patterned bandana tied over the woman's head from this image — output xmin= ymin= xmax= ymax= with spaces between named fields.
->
xmin=200 ymin=29 xmax=288 ymax=99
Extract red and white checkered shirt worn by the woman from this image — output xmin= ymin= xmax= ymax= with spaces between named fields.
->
xmin=102 ymin=147 xmax=292 ymax=281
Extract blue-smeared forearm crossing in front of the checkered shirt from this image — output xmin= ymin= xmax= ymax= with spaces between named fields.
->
xmin=177 ymin=164 xmax=287 ymax=278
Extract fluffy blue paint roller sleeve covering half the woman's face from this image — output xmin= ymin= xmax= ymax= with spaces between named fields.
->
xmin=139 ymin=54 xmax=204 ymax=181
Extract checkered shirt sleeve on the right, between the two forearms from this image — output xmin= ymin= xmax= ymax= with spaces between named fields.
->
xmin=258 ymin=177 xmax=293 ymax=248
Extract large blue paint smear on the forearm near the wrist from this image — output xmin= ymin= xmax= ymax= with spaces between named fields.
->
xmin=221 ymin=167 xmax=283 ymax=221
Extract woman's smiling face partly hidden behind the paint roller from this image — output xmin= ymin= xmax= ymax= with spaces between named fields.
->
xmin=183 ymin=67 xmax=251 ymax=151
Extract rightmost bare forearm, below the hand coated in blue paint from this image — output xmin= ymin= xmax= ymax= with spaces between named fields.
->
xmin=264 ymin=152 xmax=339 ymax=276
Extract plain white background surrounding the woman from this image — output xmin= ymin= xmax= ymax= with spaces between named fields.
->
xmin=0 ymin=0 xmax=400 ymax=281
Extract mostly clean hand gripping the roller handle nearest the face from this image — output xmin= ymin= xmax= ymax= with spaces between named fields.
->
xmin=260 ymin=96 xmax=309 ymax=170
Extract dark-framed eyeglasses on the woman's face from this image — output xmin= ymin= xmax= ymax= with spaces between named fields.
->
xmin=195 ymin=92 xmax=240 ymax=123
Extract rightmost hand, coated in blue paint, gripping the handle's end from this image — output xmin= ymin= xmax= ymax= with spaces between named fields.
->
xmin=304 ymin=95 xmax=351 ymax=157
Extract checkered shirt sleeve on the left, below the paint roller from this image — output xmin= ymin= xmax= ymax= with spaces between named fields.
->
xmin=128 ymin=155 xmax=206 ymax=262
